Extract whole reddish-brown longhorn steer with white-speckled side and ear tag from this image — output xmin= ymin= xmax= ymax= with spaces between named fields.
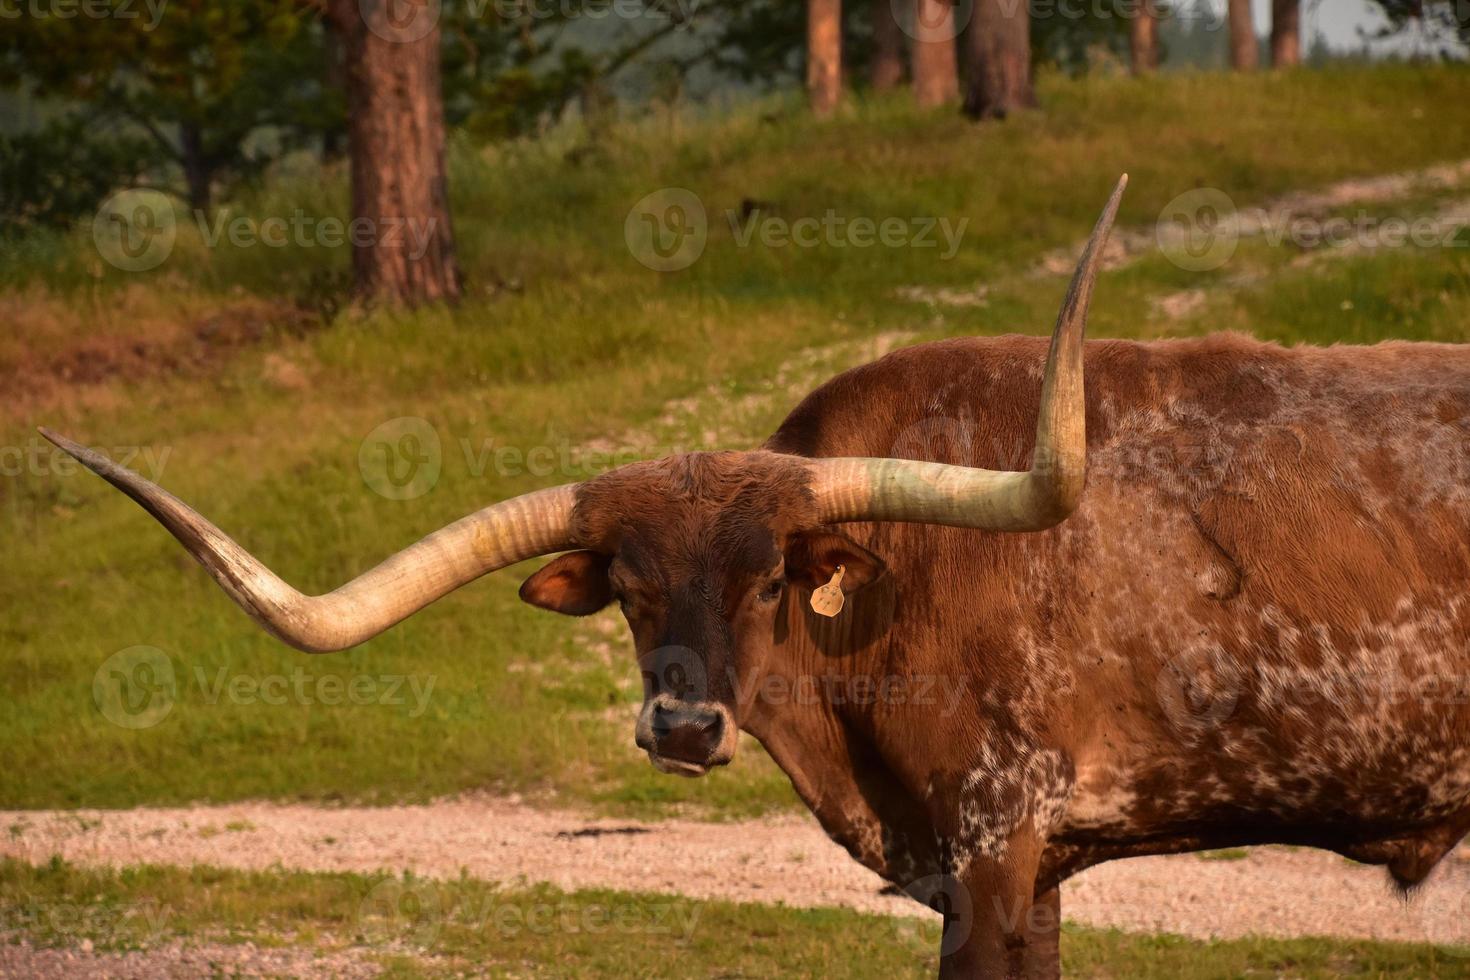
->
xmin=50 ymin=182 xmax=1470 ymax=977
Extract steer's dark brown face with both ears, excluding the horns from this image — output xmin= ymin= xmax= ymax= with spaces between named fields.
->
xmin=520 ymin=454 xmax=882 ymax=776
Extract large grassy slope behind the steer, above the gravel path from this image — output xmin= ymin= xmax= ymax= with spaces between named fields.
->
xmin=0 ymin=59 xmax=1470 ymax=817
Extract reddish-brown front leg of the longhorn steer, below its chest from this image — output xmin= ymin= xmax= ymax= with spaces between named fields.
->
xmin=939 ymin=842 xmax=1060 ymax=980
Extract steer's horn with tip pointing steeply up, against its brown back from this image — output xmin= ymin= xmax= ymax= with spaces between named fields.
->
xmin=811 ymin=173 xmax=1127 ymax=530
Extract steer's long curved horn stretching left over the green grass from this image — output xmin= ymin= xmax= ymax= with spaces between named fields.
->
xmin=40 ymin=429 xmax=576 ymax=652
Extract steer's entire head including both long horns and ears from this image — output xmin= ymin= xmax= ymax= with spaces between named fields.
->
xmin=43 ymin=178 xmax=1126 ymax=776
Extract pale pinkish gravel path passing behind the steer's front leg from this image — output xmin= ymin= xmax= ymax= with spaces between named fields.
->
xmin=0 ymin=798 xmax=1470 ymax=952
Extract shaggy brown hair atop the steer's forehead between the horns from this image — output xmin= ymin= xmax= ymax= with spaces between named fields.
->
xmin=572 ymin=451 xmax=817 ymax=564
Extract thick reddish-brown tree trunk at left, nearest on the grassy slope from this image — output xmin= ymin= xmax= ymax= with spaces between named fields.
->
xmin=331 ymin=0 xmax=460 ymax=304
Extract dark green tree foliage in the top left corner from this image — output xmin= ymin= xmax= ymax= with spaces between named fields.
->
xmin=0 ymin=0 xmax=343 ymax=207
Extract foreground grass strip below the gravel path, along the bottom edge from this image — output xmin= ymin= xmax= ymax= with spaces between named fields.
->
xmin=0 ymin=860 xmax=1470 ymax=980
